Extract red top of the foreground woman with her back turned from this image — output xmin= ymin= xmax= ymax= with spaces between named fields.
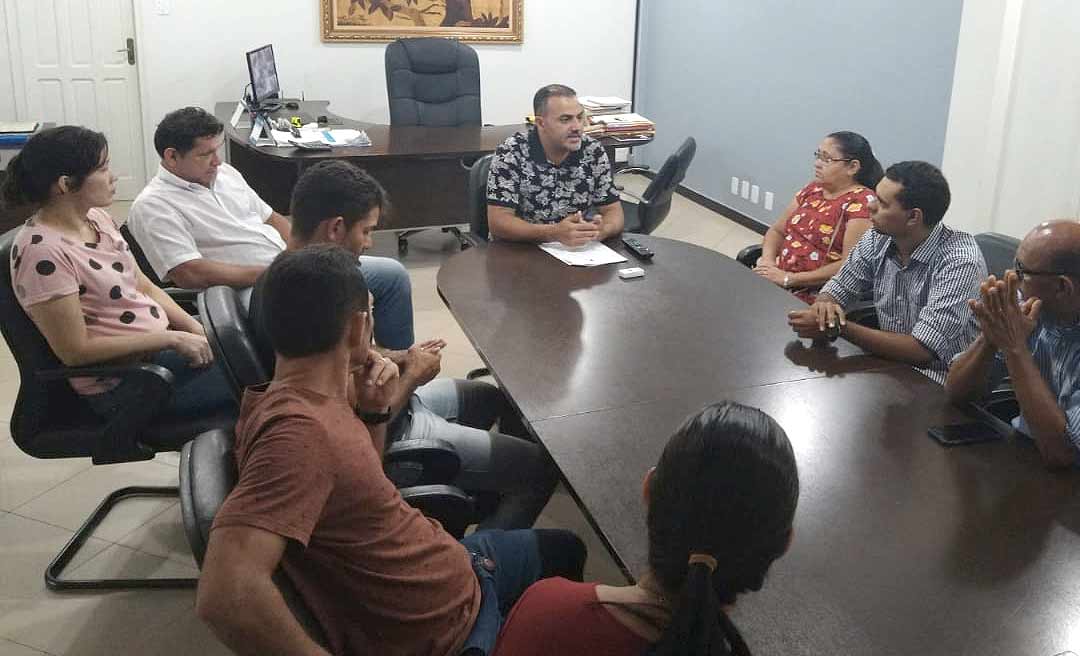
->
xmin=492 ymin=577 xmax=649 ymax=656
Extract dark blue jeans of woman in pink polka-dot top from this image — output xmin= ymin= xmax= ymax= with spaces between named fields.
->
xmin=83 ymin=350 xmax=237 ymax=418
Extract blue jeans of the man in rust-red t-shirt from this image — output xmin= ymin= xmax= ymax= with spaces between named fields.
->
xmin=461 ymin=530 xmax=543 ymax=656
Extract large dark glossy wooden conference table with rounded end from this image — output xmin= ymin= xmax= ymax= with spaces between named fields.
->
xmin=437 ymin=237 xmax=1080 ymax=656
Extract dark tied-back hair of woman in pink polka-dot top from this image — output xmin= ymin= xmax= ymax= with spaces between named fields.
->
xmin=0 ymin=125 xmax=108 ymax=207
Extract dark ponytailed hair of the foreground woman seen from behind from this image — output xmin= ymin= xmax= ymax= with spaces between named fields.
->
xmin=648 ymin=401 xmax=799 ymax=656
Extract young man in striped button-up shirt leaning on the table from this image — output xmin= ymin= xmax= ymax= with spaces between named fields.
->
xmin=787 ymin=162 xmax=986 ymax=383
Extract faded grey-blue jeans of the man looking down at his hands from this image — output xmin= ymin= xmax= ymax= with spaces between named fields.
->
xmin=391 ymin=378 xmax=558 ymax=528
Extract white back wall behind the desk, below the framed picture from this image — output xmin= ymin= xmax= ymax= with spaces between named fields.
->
xmin=135 ymin=0 xmax=635 ymax=177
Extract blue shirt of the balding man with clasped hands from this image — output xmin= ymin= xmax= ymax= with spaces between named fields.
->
xmin=991 ymin=319 xmax=1080 ymax=463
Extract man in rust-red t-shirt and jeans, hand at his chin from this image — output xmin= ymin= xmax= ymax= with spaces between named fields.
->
xmin=197 ymin=245 xmax=584 ymax=656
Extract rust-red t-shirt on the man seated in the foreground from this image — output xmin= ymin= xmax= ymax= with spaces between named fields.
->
xmin=214 ymin=384 xmax=481 ymax=656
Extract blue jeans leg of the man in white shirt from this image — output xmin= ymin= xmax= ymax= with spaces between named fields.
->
xmin=360 ymin=255 xmax=416 ymax=350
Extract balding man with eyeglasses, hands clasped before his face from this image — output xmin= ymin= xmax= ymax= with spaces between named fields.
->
xmin=945 ymin=220 xmax=1080 ymax=468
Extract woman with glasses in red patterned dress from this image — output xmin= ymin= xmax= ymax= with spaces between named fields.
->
xmin=754 ymin=132 xmax=885 ymax=303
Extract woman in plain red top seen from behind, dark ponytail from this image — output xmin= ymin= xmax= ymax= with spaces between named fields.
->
xmin=495 ymin=401 xmax=799 ymax=656
